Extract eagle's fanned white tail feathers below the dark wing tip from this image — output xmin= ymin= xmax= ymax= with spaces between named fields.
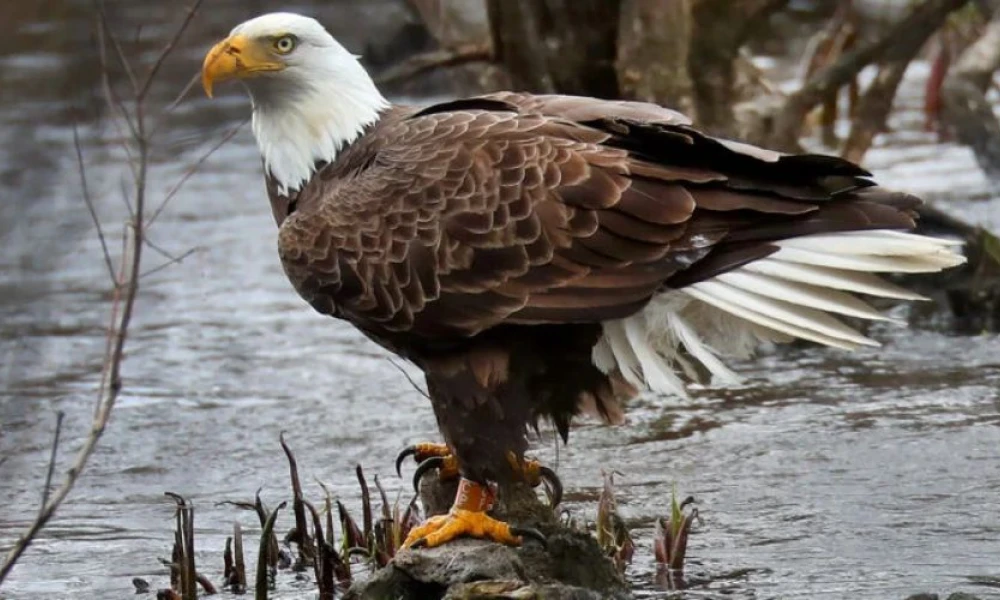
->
xmin=593 ymin=230 xmax=965 ymax=396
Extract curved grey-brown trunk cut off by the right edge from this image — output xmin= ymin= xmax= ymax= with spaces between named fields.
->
xmin=941 ymin=6 xmax=1000 ymax=180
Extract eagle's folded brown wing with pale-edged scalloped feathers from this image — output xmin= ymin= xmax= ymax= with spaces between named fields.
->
xmin=280 ymin=94 xmax=917 ymax=336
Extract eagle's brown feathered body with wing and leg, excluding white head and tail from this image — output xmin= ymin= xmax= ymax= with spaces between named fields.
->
xmin=269 ymin=93 xmax=918 ymax=481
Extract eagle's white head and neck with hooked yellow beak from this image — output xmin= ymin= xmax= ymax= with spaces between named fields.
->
xmin=201 ymin=13 xmax=389 ymax=194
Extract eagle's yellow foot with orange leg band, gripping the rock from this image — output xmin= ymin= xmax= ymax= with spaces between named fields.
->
xmin=403 ymin=477 xmax=545 ymax=548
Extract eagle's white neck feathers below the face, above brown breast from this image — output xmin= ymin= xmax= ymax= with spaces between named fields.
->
xmin=250 ymin=56 xmax=389 ymax=195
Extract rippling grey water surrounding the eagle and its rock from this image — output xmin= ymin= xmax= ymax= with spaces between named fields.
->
xmin=0 ymin=0 xmax=1000 ymax=599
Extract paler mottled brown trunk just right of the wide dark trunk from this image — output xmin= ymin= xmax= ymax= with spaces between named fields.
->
xmin=617 ymin=0 xmax=696 ymax=118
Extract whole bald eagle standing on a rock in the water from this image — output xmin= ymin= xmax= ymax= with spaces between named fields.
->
xmin=202 ymin=13 xmax=964 ymax=546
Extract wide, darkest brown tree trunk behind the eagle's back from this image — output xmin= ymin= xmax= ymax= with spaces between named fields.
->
xmin=487 ymin=0 xmax=619 ymax=98
